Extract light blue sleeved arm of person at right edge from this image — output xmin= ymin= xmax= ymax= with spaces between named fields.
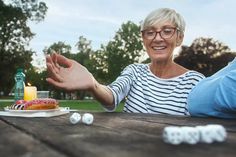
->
xmin=187 ymin=60 xmax=236 ymax=118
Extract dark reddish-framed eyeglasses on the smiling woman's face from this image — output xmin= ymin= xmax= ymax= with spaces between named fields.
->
xmin=141 ymin=27 xmax=179 ymax=40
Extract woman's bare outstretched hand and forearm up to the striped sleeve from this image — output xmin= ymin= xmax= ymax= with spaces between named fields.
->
xmin=46 ymin=53 xmax=114 ymax=109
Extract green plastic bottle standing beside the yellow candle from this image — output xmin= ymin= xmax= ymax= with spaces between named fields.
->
xmin=14 ymin=68 xmax=25 ymax=101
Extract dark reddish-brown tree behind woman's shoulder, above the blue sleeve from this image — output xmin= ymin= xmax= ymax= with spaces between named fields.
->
xmin=175 ymin=38 xmax=235 ymax=76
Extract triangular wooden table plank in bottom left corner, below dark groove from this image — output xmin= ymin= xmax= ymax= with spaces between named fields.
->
xmin=0 ymin=118 xmax=66 ymax=157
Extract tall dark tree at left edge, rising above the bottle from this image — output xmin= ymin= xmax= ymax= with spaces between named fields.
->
xmin=0 ymin=0 xmax=47 ymax=95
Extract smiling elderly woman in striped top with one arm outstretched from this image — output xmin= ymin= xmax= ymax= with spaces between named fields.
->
xmin=47 ymin=8 xmax=204 ymax=115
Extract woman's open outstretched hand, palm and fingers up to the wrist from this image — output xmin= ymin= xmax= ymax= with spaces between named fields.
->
xmin=46 ymin=53 xmax=96 ymax=90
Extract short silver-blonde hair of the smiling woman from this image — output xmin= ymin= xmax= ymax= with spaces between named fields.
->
xmin=141 ymin=8 xmax=185 ymax=33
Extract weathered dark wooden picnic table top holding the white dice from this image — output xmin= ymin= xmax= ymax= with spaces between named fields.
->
xmin=0 ymin=112 xmax=236 ymax=157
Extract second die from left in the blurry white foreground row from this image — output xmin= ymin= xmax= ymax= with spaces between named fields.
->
xmin=181 ymin=126 xmax=200 ymax=144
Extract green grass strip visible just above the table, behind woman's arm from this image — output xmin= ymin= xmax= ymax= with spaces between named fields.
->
xmin=0 ymin=99 xmax=124 ymax=112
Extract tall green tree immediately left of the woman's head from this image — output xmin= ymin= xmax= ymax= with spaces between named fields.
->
xmin=92 ymin=21 xmax=144 ymax=83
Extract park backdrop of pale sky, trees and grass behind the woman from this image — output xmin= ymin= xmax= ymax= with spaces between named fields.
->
xmin=0 ymin=0 xmax=236 ymax=111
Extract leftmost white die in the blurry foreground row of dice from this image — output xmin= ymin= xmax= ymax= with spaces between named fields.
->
xmin=163 ymin=126 xmax=183 ymax=145
